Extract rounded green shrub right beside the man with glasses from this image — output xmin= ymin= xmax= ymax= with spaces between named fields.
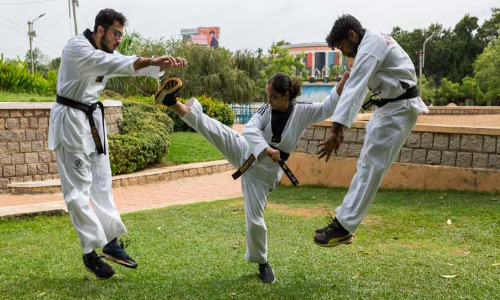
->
xmin=108 ymin=101 xmax=173 ymax=175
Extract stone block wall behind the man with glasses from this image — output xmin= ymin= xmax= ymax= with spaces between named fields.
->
xmin=0 ymin=101 xmax=123 ymax=193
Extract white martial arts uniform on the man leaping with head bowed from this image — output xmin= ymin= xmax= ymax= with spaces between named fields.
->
xmin=332 ymin=30 xmax=428 ymax=232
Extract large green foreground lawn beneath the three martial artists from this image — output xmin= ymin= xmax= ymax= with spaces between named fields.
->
xmin=0 ymin=186 xmax=500 ymax=300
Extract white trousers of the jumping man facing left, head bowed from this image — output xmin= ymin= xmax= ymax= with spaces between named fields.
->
xmin=336 ymin=100 xmax=418 ymax=232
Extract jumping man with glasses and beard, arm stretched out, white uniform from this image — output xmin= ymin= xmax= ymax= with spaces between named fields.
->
xmin=49 ymin=9 xmax=186 ymax=278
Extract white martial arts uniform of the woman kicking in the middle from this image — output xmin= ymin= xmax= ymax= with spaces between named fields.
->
xmin=182 ymin=88 xmax=339 ymax=263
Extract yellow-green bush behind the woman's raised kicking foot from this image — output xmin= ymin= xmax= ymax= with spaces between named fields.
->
xmin=164 ymin=96 xmax=234 ymax=131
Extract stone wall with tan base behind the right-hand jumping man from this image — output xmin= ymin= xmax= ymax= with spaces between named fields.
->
xmin=284 ymin=121 xmax=500 ymax=192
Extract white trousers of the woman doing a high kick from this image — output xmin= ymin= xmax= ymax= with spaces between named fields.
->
xmin=182 ymin=99 xmax=271 ymax=263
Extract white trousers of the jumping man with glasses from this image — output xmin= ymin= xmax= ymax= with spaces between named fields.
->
xmin=55 ymin=145 xmax=127 ymax=254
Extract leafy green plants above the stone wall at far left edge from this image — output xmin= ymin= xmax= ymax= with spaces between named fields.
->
xmin=0 ymin=55 xmax=57 ymax=96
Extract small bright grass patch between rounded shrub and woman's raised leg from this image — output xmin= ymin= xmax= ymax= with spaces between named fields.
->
xmin=166 ymin=132 xmax=224 ymax=164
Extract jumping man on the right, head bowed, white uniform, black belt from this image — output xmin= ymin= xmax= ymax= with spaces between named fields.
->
xmin=314 ymin=15 xmax=428 ymax=247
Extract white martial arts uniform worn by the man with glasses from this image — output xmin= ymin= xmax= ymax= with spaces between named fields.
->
xmin=49 ymin=29 xmax=160 ymax=254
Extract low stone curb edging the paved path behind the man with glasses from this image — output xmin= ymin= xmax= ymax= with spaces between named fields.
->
xmin=8 ymin=159 xmax=234 ymax=195
